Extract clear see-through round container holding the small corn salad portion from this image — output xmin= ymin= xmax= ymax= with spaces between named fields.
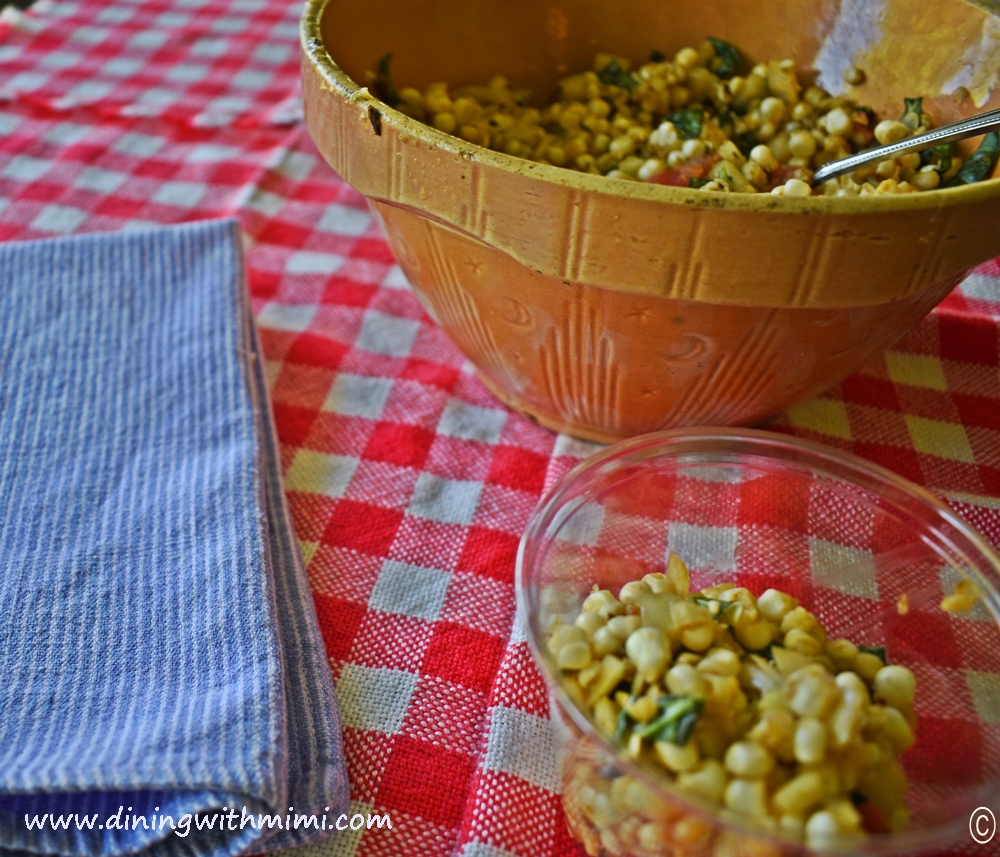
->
xmin=517 ymin=429 xmax=1000 ymax=857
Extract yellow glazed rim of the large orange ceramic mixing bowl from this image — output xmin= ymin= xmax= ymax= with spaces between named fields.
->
xmin=299 ymin=0 xmax=1000 ymax=215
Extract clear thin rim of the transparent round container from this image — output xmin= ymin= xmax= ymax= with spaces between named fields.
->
xmin=514 ymin=427 xmax=1000 ymax=857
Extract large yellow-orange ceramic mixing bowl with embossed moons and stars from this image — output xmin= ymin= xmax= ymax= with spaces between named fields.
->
xmin=302 ymin=0 xmax=1000 ymax=441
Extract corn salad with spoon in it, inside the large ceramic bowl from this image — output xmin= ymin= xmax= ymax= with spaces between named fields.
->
xmin=368 ymin=43 xmax=1000 ymax=196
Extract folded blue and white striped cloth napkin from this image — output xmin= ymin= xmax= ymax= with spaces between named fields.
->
xmin=0 ymin=221 xmax=348 ymax=857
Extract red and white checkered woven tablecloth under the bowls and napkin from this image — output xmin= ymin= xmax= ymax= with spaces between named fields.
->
xmin=0 ymin=0 xmax=1000 ymax=857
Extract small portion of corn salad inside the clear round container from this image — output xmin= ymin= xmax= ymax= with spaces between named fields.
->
xmin=546 ymin=554 xmax=916 ymax=855
